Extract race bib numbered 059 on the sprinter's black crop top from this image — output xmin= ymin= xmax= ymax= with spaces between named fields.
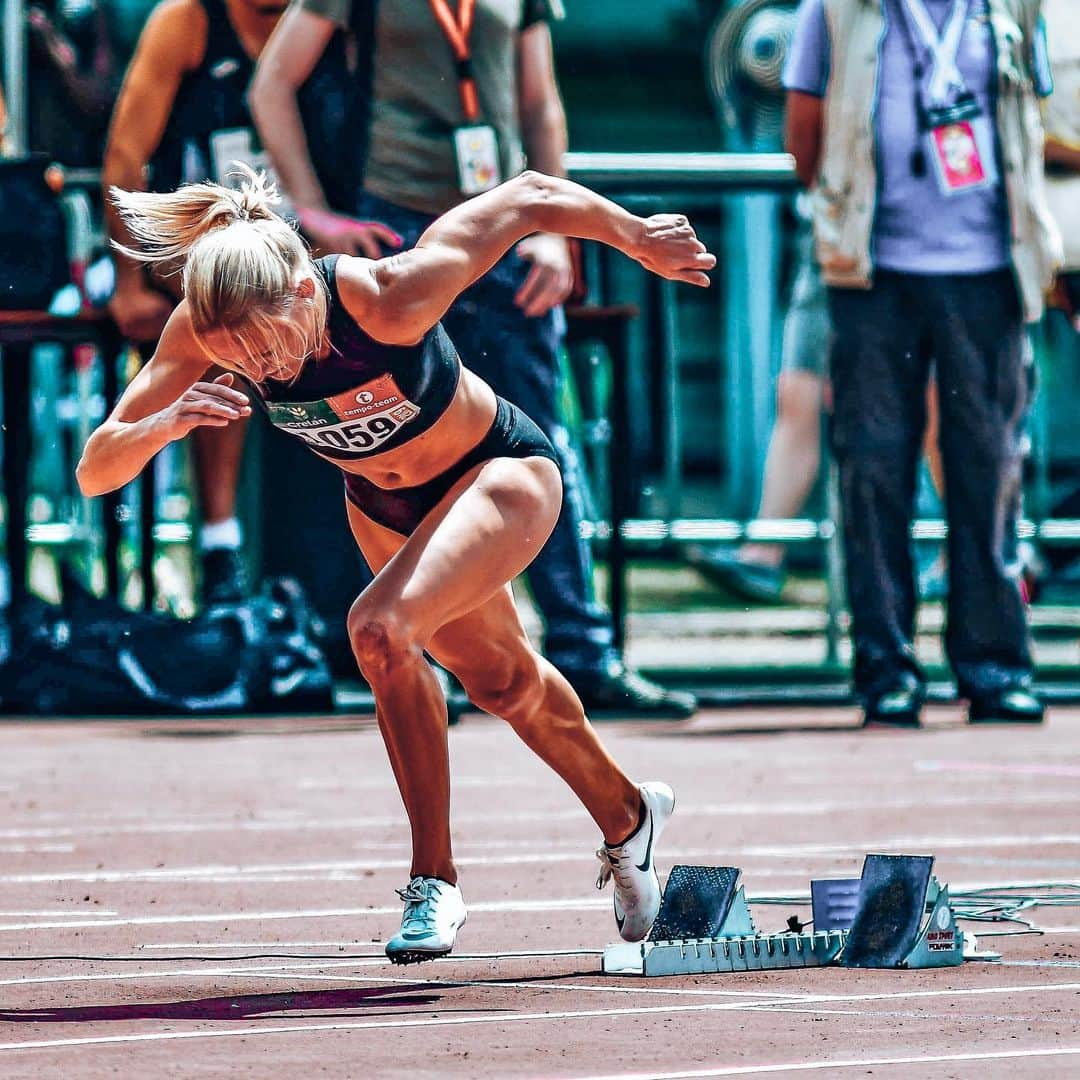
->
xmin=267 ymin=374 xmax=420 ymax=458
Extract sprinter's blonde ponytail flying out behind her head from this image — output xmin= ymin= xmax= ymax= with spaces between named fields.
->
xmin=109 ymin=162 xmax=284 ymax=264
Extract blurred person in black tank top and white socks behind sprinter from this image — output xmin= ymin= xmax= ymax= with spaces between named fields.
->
xmin=102 ymin=0 xmax=285 ymax=604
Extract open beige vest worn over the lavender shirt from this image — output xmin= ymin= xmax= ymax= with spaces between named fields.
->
xmin=813 ymin=0 xmax=1062 ymax=321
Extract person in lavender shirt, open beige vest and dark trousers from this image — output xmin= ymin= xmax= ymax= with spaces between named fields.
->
xmin=784 ymin=0 xmax=1059 ymax=727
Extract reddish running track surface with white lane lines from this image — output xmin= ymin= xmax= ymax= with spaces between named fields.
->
xmin=0 ymin=708 xmax=1080 ymax=1080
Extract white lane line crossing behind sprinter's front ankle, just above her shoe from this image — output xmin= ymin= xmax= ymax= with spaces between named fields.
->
xmin=8 ymin=833 xmax=1080 ymax=885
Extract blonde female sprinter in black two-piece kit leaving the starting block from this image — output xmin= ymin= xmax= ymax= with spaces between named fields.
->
xmin=78 ymin=173 xmax=716 ymax=963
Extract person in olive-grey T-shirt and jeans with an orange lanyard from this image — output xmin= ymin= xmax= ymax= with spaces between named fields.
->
xmin=251 ymin=0 xmax=697 ymax=717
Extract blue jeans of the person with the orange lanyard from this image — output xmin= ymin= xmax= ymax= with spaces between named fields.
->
xmin=359 ymin=193 xmax=618 ymax=674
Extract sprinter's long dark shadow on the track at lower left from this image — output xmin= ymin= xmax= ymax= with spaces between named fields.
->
xmin=0 ymin=983 xmax=451 ymax=1024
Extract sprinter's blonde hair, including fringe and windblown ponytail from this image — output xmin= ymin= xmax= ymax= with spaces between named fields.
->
xmin=110 ymin=162 xmax=327 ymax=381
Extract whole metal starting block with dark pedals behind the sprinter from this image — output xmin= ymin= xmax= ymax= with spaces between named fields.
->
xmin=603 ymin=854 xmax=998 ymax=976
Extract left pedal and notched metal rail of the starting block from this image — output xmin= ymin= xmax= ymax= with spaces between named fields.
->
xmin=603 ymin=866 xmax=845 ymax=975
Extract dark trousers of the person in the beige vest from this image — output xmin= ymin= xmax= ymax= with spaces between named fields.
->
xmin=829 ymin=270 xmax=1031 ymax=701
